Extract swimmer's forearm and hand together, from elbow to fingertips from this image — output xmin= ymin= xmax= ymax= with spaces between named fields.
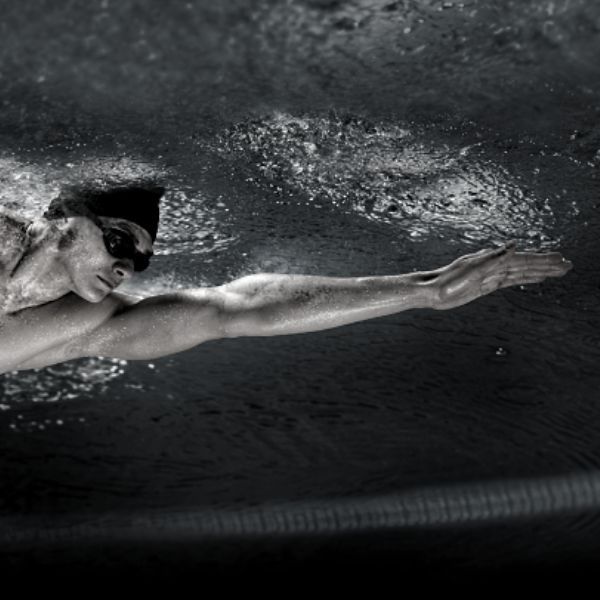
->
xmin=222 ymin=242 xmax=573 ymax=336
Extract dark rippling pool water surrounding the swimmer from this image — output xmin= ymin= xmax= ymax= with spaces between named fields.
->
xmin=0 ymin=0 xmax=600 ymax=584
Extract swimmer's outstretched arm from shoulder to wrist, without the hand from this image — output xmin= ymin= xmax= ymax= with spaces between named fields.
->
xmin=67 ymin=273 xmax=428 ymax=360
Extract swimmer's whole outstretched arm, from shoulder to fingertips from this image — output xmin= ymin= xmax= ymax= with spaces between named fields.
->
xmin=68 ymin=239 xmax=572 ymax=359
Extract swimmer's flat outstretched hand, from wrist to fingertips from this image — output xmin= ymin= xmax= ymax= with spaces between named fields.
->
xmin=428 ymin=242 xmax=573 ymax=310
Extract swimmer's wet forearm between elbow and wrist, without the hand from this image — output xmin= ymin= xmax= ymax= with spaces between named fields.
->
xmin=221 ymin=273 xmax=434 ymax=337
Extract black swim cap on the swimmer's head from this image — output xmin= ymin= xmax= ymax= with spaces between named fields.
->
xmin=44 ymin=186 xmax=165 ymax=242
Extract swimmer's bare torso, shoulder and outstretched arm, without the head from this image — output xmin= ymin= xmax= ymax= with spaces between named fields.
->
xmin=0 ymin=209 xmax=573 ymax=373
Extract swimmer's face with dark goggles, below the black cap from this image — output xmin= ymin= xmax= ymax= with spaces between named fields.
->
xmin=58 ymin=216 xmax=152 ymax=302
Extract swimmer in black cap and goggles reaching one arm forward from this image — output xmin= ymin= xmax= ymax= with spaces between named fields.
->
xmin=0 ymin=187 xmax=573 ymax=373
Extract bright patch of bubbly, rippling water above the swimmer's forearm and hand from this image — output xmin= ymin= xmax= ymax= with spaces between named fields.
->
xmin=222 ymin=113 xmax=556 ymax=249
